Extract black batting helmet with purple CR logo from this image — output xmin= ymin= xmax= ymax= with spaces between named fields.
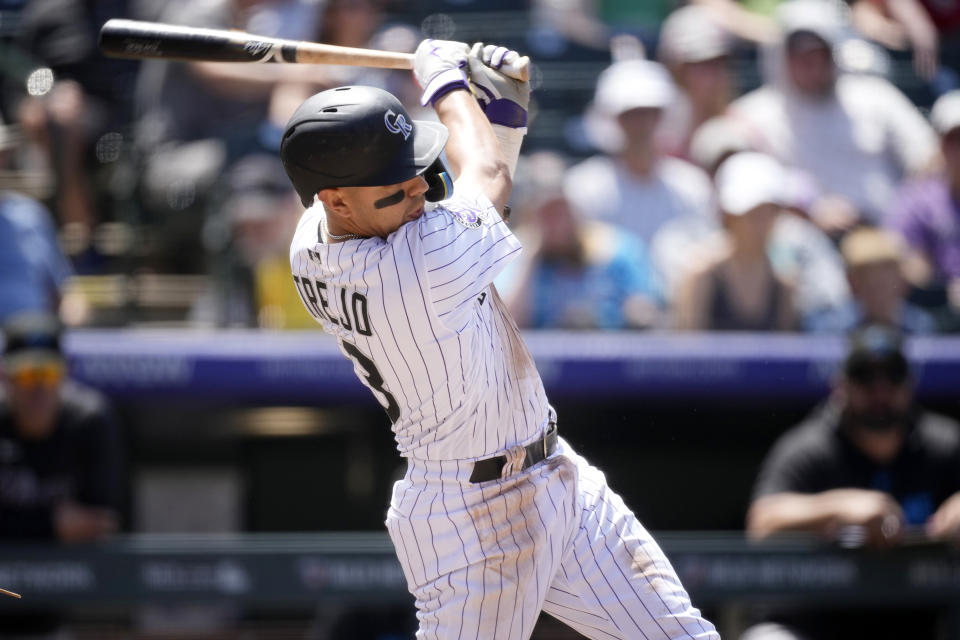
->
xmin=280 ymin=86 xmax=448 ymax=207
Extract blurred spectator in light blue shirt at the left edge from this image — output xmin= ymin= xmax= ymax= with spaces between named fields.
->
xmin=0 ymin=117 xmax=72 ymax=324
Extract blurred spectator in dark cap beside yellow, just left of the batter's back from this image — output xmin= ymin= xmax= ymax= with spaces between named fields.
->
xmin=192 ymin=153 xmax=316 ymax=329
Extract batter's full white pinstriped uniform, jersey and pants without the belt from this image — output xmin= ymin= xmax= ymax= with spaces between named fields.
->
xmin=290 ymin=188 xmax=719 ymax=640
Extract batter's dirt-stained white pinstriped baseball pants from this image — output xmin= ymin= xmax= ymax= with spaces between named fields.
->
xmin=387 ymin=438 xmax=720 ymax=640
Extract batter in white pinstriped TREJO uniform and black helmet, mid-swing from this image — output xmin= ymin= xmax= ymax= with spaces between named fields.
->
xmin=281 ymin=40 xmax=719 ymax=640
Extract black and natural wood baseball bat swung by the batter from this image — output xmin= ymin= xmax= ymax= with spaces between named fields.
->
xmin=99 ymin=18 xmax=530 ymax=81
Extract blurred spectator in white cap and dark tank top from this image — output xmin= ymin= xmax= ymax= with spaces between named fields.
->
xmin=673 ymin=152 xmax=798 ymax=331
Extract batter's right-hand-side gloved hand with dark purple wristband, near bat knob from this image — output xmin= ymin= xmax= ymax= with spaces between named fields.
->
xmin=468 ymin=42 xmax=530 ymax=129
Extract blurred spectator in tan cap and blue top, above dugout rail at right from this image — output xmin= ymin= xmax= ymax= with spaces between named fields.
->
xmin=809 ymin=227 xmax=937 ymax=334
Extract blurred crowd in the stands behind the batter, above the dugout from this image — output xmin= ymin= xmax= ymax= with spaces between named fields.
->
xmin=0 ymin=0 xmax=960 ymax=334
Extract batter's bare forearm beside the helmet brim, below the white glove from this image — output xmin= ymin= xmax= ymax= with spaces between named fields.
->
xmin=434 ymin=90 xmax=512 ymax=211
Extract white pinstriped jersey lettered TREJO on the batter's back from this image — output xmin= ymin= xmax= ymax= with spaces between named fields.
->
xmin=290 ymin=188 xmax=551 ymax=460
